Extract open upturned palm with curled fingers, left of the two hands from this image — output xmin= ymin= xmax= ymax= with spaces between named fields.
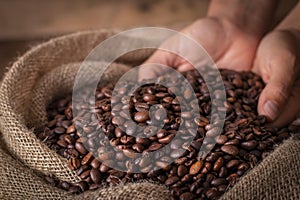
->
xmin=139 ymin=17 xmax=260 ymax=79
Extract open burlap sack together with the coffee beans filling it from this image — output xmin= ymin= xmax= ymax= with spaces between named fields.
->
xmin=0 ymin=31 xmax=300 ymax=199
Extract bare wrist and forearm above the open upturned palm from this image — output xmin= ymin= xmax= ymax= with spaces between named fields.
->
xmin=207 ymin=0 xmax=277 ymax=37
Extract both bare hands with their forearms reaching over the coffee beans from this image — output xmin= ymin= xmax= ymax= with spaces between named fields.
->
xmin=139 ymin=0 xmax=300 ymax=126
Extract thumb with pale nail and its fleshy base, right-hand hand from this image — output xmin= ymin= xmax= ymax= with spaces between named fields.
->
xmin=254 ymin=31 xmax=298 ymax=121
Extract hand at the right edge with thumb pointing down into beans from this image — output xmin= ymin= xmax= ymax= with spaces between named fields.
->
xmin=254 ymin=29 xmax=300 ymax=126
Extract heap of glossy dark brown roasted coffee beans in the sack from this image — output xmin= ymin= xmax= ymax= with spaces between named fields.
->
xmin=37 ymin=70 xmax=292 ymax=199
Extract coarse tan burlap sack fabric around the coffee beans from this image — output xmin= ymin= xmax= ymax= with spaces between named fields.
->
xmin=0 ymin=31 xmax=300 ymax=199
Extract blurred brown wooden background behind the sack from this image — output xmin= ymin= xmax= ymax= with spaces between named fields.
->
xmin=0 ymin=0 xmax=297 ymax=79
